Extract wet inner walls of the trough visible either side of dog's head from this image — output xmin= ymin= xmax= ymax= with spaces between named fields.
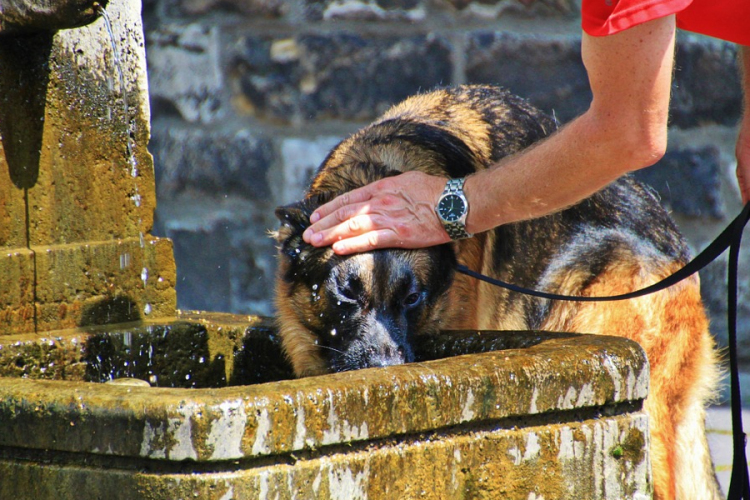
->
xmin=0 ymin=320 xmax=575 ymax=389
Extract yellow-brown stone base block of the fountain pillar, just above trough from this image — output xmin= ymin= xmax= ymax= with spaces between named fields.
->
xmin=0 ymin=235 xmax=177 ymax=335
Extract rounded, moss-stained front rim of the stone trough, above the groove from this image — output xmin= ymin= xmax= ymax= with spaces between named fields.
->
xmin=0 ymin=328 xmax=648 ymax=462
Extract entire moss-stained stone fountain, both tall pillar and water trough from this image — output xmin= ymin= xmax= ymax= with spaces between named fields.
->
xmin=0 ymin=0 xmax=651 ymax=500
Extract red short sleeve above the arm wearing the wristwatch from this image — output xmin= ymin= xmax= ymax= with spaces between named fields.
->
xmin=581 ymin=0 xmax=692 ymax=36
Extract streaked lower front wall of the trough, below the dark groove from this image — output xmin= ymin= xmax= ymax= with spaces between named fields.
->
xmin=0 ymin=412 xmax=652 ymax=500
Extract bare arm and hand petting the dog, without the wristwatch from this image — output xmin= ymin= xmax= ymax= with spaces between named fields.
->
xmin=305 ymin=16 xmax=675 ymax=254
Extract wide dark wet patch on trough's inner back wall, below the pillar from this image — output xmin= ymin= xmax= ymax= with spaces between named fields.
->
xmin=82 ymin=323 xmax=227 ymax=389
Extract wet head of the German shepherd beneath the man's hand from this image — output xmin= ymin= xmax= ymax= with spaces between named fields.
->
xmin=276 ymin=197 xmax=456 ymax=376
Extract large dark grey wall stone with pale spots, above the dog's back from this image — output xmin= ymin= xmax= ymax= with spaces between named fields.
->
xmin=232 ymin=33 xmax=452 ymax=123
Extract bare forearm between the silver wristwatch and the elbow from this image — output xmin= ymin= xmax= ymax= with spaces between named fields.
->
xmin=465 ymin=110 xmax=662 ymax=233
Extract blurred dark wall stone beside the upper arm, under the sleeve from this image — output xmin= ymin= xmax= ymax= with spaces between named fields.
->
xmin=466 ymin=31 xmax=591 ymax=122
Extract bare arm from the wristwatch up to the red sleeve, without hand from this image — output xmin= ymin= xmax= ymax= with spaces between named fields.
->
xmin=465 ymin=17 xmax=674 ymax=232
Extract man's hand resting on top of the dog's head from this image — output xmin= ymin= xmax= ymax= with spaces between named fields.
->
xmin=302 ymin=171 xmax=450 ymax=255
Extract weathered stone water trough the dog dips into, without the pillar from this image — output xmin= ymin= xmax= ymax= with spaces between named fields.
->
xmin=0 ymin=314 xmax=651 ymax=500
